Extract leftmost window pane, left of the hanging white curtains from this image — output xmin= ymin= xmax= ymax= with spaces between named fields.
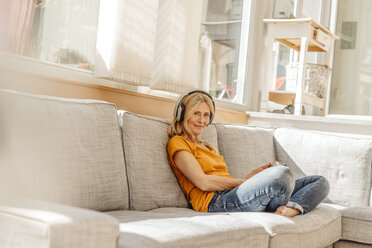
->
xmin=0 ymin=0 xmax=99 ymax=70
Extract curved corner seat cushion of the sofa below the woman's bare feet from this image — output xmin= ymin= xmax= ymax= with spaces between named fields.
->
xmin=254 ymin=204 xmax=341 ymax=248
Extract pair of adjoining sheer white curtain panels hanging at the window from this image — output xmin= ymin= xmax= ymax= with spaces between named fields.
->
xmin=95 ymin=0 xmax=203 ymax=92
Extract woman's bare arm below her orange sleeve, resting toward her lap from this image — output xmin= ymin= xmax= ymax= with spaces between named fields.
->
xmin=173 ymin=151 xmax=246 ymax=191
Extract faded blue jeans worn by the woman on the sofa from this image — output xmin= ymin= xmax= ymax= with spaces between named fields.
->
xmin=208 ymin=166 xmax=329 ymax=214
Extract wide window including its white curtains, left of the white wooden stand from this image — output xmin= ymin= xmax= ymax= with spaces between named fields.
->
xmin=0 ymin=0 xmax=252 ymax=107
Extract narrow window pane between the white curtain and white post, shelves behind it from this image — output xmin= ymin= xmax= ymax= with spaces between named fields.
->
xmin=200 ymin=0 xmax=251 ymax=103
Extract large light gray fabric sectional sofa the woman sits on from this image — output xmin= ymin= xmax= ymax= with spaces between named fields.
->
xmin=0 ymin=90 xmax=372 ymax=248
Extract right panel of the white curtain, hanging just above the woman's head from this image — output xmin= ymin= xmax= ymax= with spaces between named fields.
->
xmin=150 ymin=0 xmax=203 ymax=92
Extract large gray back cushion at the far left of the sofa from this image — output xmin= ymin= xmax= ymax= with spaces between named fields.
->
xmin=0 ymin=90 xmax=128 ymax=211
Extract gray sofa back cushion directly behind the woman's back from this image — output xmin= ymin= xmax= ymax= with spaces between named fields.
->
xmin=119 ymin=112 xmax=218 ymax=210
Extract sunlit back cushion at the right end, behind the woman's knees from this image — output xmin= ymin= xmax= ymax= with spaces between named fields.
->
xmin=275 ymin=128 xmax=372 ymax=206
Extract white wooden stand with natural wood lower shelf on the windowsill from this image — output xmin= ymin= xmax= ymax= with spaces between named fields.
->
xmin=262 ymin=18 xmax=339 ymax=115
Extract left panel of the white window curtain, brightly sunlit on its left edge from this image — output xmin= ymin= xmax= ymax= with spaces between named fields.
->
xmin=95 ymin=0 xmax=158 ymax=85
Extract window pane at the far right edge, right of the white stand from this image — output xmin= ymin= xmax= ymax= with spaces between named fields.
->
xmin=329 ymin=0 xmax=372 ymax=116
